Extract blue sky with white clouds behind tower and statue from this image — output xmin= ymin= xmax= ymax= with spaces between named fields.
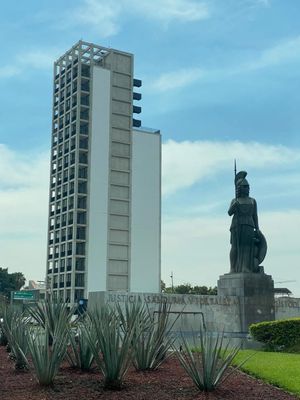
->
xmin=0 ymin=0 xmax=300 ymax=296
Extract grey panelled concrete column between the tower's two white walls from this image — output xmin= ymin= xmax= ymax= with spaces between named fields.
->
xmin=105 ymin=50 xmax=133 ymax=290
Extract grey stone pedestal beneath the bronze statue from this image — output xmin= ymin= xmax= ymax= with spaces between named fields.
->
xmin=218 ymin=273 xmax=275 ymax=333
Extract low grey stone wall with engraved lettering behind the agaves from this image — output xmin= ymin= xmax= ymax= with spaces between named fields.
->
xmin=88 ymin=292 xmax=300 ymax=337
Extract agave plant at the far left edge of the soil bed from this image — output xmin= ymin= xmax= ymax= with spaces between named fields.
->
xmin=1 ymin=307 xmax=28 ymax=370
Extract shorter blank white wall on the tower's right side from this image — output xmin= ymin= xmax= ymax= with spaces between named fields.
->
xmin=129 ymin=131 xmax=161 ymax=293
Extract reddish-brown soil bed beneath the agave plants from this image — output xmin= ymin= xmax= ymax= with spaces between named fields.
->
xmin=0 ymin=347 xmax=299 ymax=400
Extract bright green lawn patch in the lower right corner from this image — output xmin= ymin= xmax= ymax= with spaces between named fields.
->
xmin=233 ymin=350 xmax=300 ymax=395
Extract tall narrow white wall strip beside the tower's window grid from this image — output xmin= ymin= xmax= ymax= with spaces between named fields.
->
xmin=86 ymin=67 xmax=111 ymax=292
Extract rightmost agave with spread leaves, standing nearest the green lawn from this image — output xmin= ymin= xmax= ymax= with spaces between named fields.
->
xmin=173 ymin=329 xmax=240 ymax=392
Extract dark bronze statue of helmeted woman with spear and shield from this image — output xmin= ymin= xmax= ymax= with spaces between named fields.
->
xmin=228 ymin=171 xmax=267 ymax=273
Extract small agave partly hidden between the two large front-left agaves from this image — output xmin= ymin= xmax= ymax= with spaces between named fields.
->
xmin=66 ymin=317 xmax=96 ymax=371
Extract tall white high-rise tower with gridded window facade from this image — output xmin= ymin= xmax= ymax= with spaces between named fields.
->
xmin=47 ymin=41 xmax=161 ymax=303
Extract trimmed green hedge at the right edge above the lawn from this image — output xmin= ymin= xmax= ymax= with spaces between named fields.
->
xmin=250 ymin=318 xmax=300 ymax=350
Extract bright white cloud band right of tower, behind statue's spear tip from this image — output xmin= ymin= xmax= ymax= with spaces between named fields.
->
xmin=162 ymin=140 xmax=300 ymax=196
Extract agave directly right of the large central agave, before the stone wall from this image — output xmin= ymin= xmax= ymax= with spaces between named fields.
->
xmin=133 ymin=304 xmax=179 ymax=370
